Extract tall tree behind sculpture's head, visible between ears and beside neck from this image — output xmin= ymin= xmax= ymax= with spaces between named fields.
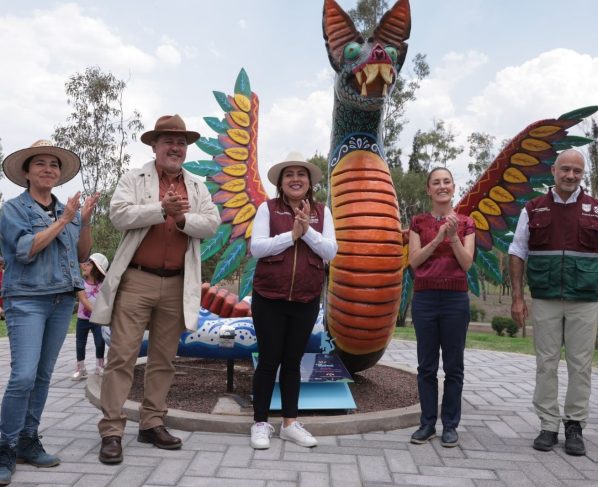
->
xmin=347 ymin=0 xmax=430 ymax=167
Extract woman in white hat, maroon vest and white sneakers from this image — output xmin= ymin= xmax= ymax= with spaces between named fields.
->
xmin=251 ymin=152 xmax=337 ymax=449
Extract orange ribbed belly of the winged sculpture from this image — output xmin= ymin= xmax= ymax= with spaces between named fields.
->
xmin=326 ymin=150 xmax=403 ymax=371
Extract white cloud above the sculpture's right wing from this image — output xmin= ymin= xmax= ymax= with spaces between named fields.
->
xmin=401 ymin=49 xmax=598 ymax=196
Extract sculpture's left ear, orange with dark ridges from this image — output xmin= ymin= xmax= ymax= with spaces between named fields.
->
xmin=322 ymin=0 xmax=363 ymax=72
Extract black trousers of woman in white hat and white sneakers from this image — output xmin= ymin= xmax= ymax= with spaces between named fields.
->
xmin=251 ymin=292 xmax=320 ymax=422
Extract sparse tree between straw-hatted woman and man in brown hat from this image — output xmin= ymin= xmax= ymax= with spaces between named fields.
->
xmin=52 ymin=66 xmax=143 ymax=259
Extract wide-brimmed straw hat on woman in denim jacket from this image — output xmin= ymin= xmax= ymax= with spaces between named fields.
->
xmin=2 ymin=140 xmax=81 ymax=188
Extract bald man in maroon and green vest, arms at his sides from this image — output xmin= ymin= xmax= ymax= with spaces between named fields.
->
xmin=509 ymin=149 xmax=598 ymax=455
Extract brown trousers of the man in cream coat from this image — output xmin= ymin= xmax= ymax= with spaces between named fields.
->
xmin=98 ymin=269 xmax=185 ymax=437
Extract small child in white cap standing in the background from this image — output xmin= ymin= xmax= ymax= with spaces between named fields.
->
xmin=71 ymin=253 xmax=108 ymax=380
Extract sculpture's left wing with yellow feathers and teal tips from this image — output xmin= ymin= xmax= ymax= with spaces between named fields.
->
xmin=184 ymin=69 xmax=268 ymax=299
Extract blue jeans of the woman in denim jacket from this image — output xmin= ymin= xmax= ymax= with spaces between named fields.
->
xmin=0 ymin=293 xmax=75 ymax=447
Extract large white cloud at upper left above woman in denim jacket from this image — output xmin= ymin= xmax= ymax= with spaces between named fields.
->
xmin=0 ymin=3 xmax=155 ymax=157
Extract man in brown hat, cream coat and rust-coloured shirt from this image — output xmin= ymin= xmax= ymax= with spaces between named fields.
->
xmin=91 ymin=115 xmax=220 ymax=464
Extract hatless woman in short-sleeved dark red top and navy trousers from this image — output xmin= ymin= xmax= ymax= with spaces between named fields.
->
xmin=409 ymin=167 xmax=475 ymax=447
